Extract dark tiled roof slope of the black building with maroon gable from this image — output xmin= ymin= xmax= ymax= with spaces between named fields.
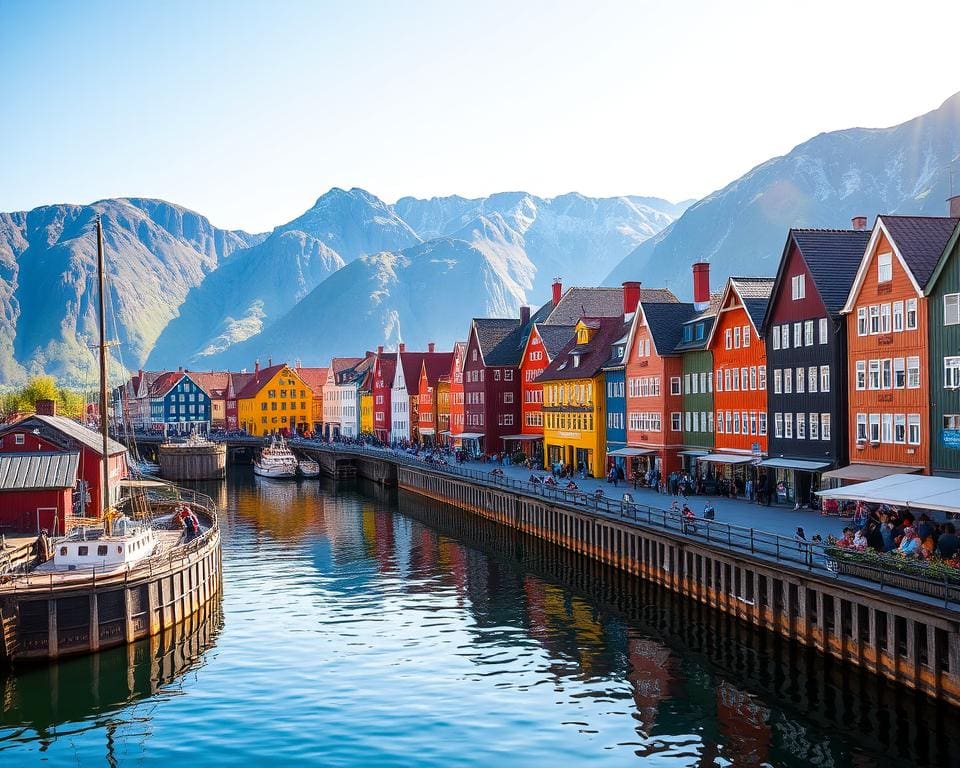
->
xmin=784 ymin=229 xmax=870 ymax=315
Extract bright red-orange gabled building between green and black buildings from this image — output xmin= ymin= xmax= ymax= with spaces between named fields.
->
xmin=699 ymin=277 xmax=774 ymax=481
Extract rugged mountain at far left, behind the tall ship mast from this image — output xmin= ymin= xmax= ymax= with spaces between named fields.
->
xmin=0 ymin=198 xmax=261 ymax=383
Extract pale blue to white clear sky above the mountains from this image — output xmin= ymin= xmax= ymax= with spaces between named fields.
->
xmin=0 ymin=0 xmax=960 ymax=232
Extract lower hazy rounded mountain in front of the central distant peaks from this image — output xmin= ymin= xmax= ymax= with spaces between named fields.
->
xmin=207 ymin=238 xmax=524 ymax=368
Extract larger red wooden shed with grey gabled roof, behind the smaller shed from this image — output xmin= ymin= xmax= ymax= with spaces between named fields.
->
xmin=0 ymin=412 xmax=127 ymax=531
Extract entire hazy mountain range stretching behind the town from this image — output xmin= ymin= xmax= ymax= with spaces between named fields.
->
xmin=0 ymin=94 xmax=960 ymax=384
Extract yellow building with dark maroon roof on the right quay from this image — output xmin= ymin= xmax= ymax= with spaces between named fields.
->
xmin=537 ymin=316 xmax=628 ymax=478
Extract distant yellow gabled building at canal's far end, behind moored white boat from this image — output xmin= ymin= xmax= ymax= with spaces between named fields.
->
xmin=237 ymin=363 xmax=313 ymax=436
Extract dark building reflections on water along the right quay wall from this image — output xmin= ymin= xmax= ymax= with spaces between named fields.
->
xmin=380 ymin=484 xmax=960 ymax=765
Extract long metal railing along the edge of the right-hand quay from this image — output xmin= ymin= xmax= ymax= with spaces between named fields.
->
xmin=295 ymin=440 xmax=960 ymax=605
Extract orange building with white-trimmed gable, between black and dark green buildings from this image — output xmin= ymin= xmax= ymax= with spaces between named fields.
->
xmin=830 ymin=216 xmax=952 ymax=480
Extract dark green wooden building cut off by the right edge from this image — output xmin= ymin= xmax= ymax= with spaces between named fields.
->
xmin=924 ymin=207 xmax=960 ymax=477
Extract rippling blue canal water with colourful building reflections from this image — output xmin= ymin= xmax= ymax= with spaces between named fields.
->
xmin=0 ymin=472 xmax=960 ymax=768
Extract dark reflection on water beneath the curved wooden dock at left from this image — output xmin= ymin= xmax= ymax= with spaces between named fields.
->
xmin=0 ymin=599 xmax=223 ymax=752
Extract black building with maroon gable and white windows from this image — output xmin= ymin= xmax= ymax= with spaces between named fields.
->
xmin=761 ymin=226 xmax=870 ymax=504
